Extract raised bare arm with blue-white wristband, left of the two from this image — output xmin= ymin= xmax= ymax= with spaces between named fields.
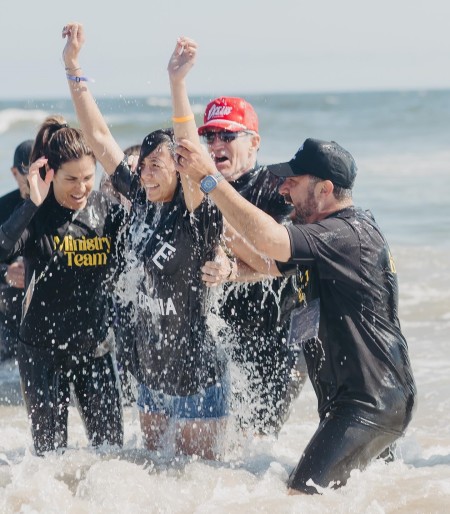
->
xmin=62 ymin=23 xmax=124 ymax=175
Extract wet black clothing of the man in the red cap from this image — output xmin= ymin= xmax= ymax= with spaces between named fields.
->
xmin=220 ymin=165 xmax=306 ymax=433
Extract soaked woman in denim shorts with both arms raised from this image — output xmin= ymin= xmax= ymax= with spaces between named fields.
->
xmin=63 ymin=23 xmax=228 ymax=459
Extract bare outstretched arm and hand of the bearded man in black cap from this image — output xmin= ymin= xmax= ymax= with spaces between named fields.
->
xmin=172 ymin=139 xmax=291 ymax=262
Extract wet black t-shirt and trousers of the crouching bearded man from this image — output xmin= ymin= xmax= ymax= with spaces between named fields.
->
xmin=279 ymin=207 xmax=416 ymax=490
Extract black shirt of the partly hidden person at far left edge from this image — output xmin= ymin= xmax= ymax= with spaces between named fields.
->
xmin=0 ymin=189 xmax=23 ymax=324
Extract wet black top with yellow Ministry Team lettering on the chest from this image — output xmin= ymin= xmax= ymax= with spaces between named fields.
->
xmin=0 ymin=191 xmax=124 ymax=353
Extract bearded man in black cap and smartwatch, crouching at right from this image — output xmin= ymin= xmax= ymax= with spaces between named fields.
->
xmin=177 ymin=135 xmax=416 ymax=493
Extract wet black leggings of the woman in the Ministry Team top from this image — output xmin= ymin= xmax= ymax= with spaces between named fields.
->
xmin=17 ymin=342 xmax=123 ymax=455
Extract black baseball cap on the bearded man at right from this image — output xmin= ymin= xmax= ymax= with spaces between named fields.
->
xmin=267 ymin=138 xmax=357 ymax=189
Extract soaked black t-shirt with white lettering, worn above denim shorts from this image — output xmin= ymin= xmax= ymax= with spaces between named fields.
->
xmin=112 ymin=162 xmax=222 ymax=396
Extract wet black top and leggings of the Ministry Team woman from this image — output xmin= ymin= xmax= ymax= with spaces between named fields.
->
xmin=0 ymin=191 xmax=123 ymax=453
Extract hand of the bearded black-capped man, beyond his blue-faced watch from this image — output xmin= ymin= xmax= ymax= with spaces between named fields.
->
xmin=175 ymin=139 xmax=217 ymax=184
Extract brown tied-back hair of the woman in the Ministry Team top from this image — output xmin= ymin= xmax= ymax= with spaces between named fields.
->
xmin=30 ymin=115 xmax=96 ymax=175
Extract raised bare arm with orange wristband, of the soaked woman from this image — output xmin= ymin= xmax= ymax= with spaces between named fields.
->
xmin=167 ymin=37 xmax=203 ymax=212
